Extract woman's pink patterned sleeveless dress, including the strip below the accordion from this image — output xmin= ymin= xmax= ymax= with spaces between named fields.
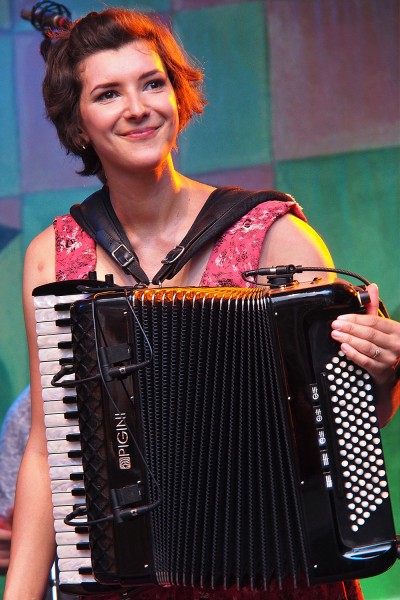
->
xmin=53 ymin=200 xmax=363 ymax=600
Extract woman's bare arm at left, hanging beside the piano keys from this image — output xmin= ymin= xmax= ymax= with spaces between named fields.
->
xmin=4 ymin=228 xmax=55 ymax=600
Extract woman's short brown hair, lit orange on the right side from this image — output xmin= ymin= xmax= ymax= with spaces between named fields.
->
xmin=43 ymin=8 xmax=206 ymax=175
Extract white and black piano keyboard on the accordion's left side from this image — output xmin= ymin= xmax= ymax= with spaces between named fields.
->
xmin=34 ymin=294 xmax=96 ymax=588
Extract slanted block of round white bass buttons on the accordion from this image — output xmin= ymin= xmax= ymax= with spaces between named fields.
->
xmin=326 ymin=351 xmax=389 ymax=531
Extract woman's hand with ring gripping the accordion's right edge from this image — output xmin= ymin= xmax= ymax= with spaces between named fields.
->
xmin=332 ymin=284 xmax=400 ymax=425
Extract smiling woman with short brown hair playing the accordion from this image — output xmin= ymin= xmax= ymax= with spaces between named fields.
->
xmin=5 ymin=9 xmax=400 ymax=600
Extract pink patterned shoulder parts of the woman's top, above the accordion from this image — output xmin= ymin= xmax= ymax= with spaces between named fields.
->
xmin=53 ymin=200 xmax=305 ymax=287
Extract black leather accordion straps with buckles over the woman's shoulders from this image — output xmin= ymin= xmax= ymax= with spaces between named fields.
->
xmin=70 ymin=186 xmax=293 ymax=285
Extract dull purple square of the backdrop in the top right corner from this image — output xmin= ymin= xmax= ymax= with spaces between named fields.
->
xmin=267 ymin=0 xmax=400 ymax=160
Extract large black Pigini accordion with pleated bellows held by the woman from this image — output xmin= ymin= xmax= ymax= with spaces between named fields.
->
xmin=34 ymin=280 xmax=396 ymax=593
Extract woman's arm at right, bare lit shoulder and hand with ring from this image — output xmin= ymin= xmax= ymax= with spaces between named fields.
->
xmin=260 ymin=215 xmax=400 ymax=427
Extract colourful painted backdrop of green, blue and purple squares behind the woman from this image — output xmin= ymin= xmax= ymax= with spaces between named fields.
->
xmin=0 ymin=0 xmax=400 ymax=600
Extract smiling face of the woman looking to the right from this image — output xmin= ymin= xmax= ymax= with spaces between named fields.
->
xmin=80 ymin=41 xmax=179 ymax=176
